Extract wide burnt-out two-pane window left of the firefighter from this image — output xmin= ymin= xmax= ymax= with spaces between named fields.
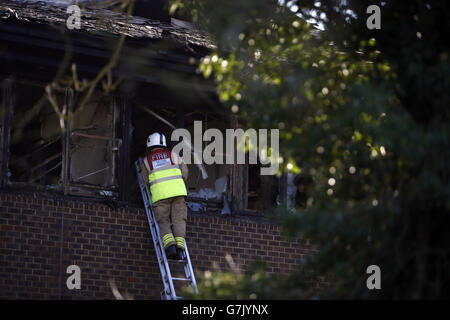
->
xmin=1 ymin=81 xmax=126 ymax=198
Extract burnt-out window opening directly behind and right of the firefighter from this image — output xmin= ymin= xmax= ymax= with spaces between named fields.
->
xmin=125 ymin=102 xmax=279 ymax=213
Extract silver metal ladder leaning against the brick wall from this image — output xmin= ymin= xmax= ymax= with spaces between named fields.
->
xmin=134 ymin=158 xmax=198 ymax=300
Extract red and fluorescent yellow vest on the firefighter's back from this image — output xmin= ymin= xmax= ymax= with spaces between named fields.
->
xmin=144 ymin=149 xmax=187 ymax=203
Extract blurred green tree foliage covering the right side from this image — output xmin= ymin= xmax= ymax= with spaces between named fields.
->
xmin=169 ymin=0 xmax=450 ymax=299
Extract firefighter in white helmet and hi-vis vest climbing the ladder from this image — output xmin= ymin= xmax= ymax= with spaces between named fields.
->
xmin=141 ymin=132 xmax=188 ymax=260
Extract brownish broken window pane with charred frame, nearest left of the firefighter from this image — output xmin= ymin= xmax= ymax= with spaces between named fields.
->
xmin=61 ymin=92 xmax=122 ymax=197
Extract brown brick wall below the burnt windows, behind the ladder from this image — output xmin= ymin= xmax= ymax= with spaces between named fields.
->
xmin=0 ymin=193 xmax=312 ymax=299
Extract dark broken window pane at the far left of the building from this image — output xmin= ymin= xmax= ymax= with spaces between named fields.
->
xmin=3 ymin=83 xmax=62 ymax=189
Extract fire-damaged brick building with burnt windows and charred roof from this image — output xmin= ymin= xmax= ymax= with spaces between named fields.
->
xmin=0 ymin=0 xmax=314 ymax=299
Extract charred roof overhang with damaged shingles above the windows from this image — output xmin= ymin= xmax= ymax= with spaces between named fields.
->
xmin=0 ymin=0 xmax=223 ymax=112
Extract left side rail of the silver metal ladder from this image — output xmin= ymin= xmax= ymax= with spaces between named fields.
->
xmin=135 ymin=158 xmax=176 ymax=299
